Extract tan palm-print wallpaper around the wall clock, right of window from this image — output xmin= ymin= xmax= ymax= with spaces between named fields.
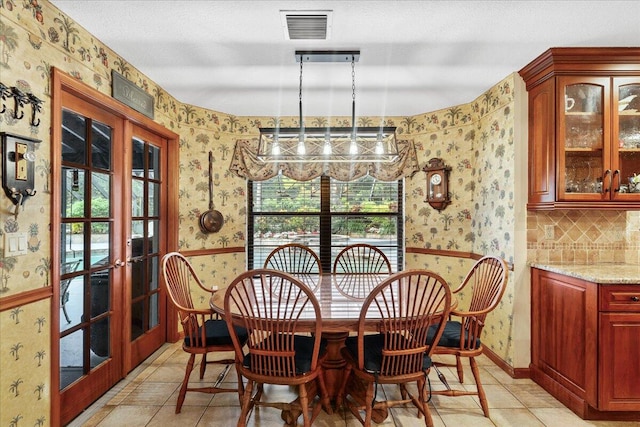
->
xmin=403 ymin=74 xmax=516 ymax=365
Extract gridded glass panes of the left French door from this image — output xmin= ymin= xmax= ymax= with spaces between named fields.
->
xmin=59 ymin=110 xmax=113 ymax=390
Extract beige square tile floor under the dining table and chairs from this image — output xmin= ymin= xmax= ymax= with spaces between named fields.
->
xmin=69 ymin=343 xmax=640 ymax=427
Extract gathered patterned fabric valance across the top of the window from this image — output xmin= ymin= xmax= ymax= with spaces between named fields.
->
xmin=229 ymin=138 xmax=420 ymax=181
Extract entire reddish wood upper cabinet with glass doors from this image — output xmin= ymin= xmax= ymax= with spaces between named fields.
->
xmin=520 ymin=48 xmax=640 ymax=210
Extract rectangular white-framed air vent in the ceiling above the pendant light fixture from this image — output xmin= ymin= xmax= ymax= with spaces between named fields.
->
xmin=280 ymin=10 xmax=333 ymax=40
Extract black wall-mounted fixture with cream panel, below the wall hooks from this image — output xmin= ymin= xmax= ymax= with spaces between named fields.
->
xmin=0 ymin=132 xmax=40 ymax=218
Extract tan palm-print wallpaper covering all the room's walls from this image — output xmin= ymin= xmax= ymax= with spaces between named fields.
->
xmin=0 ymin=0 xmax=639 ymax=426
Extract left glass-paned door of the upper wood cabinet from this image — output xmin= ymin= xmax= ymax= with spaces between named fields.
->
xmin=557 ymin=77 xmax=612 ymax=201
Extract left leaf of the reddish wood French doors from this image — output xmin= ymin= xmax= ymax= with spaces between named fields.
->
xmin=54 ymin=93 xmax=126 ymax=424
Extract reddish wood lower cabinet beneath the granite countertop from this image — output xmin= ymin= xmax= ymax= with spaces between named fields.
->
xmin=531 ymin=268 xmax=640 ymax=420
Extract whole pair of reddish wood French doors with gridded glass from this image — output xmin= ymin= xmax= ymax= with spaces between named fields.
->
xmin=52 ymin=73 xmax=177 ymax=425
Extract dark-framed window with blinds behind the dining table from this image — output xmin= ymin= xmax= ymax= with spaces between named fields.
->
xmin=247 ymin=175 xmax=404 ymax=271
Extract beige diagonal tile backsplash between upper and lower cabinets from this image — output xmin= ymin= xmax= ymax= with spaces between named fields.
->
xmin=527 ymin=210 xmax=640 ymax=264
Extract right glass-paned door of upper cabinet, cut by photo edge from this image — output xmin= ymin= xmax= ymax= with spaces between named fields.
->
xmin=612 ymin=78 xmax=640 ymax=199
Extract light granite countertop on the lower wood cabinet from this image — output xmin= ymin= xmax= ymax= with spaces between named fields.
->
xmin=530 ymin=263 xmax=640 ymax=285
